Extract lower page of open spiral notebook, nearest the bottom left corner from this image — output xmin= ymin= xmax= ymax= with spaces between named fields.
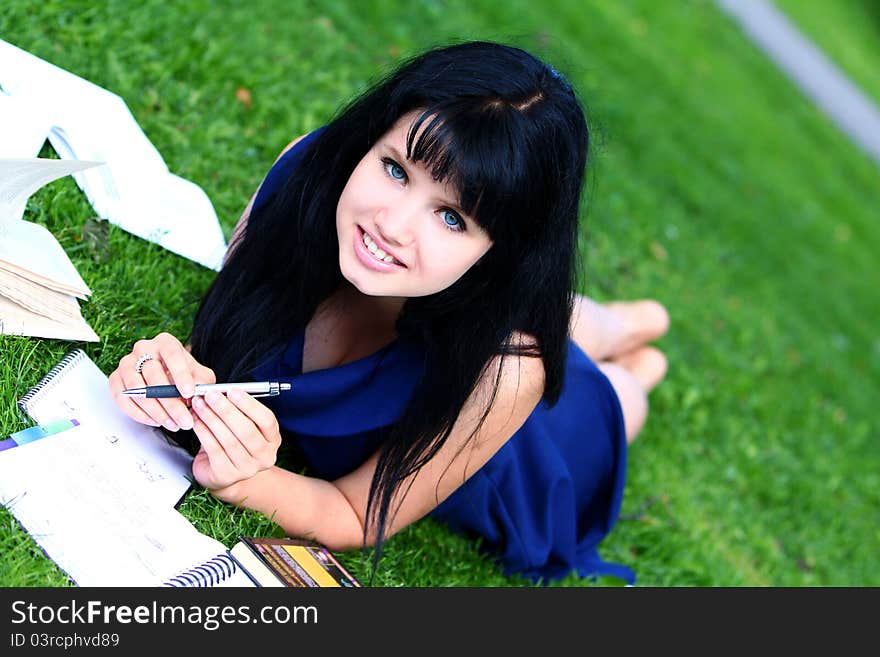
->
xmin=0 ymin=424 xmax=253 ymax=586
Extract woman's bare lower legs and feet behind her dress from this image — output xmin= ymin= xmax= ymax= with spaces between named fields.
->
xmin=571 ymin=295 xmax=669 ymax=442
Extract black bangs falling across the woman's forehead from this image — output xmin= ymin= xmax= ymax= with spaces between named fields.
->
xmin=406 ymin=104 xmax=546 ymax=241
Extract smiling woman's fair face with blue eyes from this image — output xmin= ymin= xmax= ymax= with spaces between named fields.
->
xmin=336 ymin=112 xmax=492 ymax=297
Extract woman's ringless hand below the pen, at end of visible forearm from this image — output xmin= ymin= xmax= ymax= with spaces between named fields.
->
xmin=192 ymin=390 xmax=281 ymax=490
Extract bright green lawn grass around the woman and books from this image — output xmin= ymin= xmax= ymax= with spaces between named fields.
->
xmin=0 ymin=0 xmax=880 ymax=586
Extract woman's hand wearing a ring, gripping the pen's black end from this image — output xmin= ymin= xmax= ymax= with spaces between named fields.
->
xmin=109 ymin=333 xmax=216 ymax=431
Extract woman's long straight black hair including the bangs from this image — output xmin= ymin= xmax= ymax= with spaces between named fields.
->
xmin=190 ymin=42 xmax=588 ymax=559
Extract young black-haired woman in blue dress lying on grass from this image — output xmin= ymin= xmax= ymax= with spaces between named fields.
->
xmin=110 ymin=42 xmax=668 ymax=581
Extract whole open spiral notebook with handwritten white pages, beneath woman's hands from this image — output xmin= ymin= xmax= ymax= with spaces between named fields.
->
xmin=0 ymin=350 xmax=255 ymax=586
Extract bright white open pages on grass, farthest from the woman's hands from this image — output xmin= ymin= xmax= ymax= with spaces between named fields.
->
xmin=0 ymin=40 xmax=226 ymax=270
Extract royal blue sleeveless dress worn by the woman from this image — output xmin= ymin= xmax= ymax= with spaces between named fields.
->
xmin=246 ymin=132 xmax=635 ymax=583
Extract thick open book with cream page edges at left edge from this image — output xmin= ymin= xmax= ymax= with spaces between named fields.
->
xmin=0 ymin=158 xmax=99 ymax=342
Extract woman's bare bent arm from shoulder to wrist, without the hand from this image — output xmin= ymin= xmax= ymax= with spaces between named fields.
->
xmin=213 ymin=340 xmax=544 ymax=550
